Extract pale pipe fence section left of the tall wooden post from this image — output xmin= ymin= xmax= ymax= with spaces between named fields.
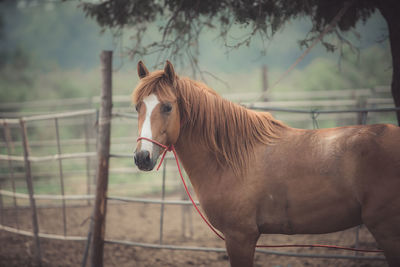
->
xmin=0 ymin=109 xmax=97 ymax=266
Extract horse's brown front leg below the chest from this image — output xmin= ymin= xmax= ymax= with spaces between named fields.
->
xmin=225 ymin=233 xmax=260 ymax=267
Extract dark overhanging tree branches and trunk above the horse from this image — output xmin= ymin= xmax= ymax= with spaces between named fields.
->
xmin=76 ymin=0 xmax=400 ymax=124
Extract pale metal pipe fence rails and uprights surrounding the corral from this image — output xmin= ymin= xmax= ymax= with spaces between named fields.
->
xmin=0 ymin=103 xmax=400 ymax=262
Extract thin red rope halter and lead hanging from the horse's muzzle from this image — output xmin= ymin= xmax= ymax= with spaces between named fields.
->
xmin=136 ymin=137 xmax=383 ymax=253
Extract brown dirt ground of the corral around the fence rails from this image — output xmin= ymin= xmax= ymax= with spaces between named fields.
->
xmin=0 ymin=203 xmax=387 ymax=267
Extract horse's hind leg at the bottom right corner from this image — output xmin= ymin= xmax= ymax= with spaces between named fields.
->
xmin=362 ymin=197 xmax=400 ymax=267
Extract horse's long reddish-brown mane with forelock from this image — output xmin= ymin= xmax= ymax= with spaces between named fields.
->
xmin=132 ymin=71 xmax=287 ymax=175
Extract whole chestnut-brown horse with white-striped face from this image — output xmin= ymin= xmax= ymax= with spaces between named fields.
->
xmin=132 ymin=61 xmax=400 ymax=267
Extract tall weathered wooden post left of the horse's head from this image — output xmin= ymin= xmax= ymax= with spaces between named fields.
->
xmin=91 ymin=51 xmax=112 ymax=267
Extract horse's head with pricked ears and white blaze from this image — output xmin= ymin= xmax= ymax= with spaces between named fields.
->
xmin=133 ymin=61 xmax=180 ymax=171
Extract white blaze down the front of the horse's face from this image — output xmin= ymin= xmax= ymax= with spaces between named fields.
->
xmin=139 ymin=94 xmax=160 ymax=157
